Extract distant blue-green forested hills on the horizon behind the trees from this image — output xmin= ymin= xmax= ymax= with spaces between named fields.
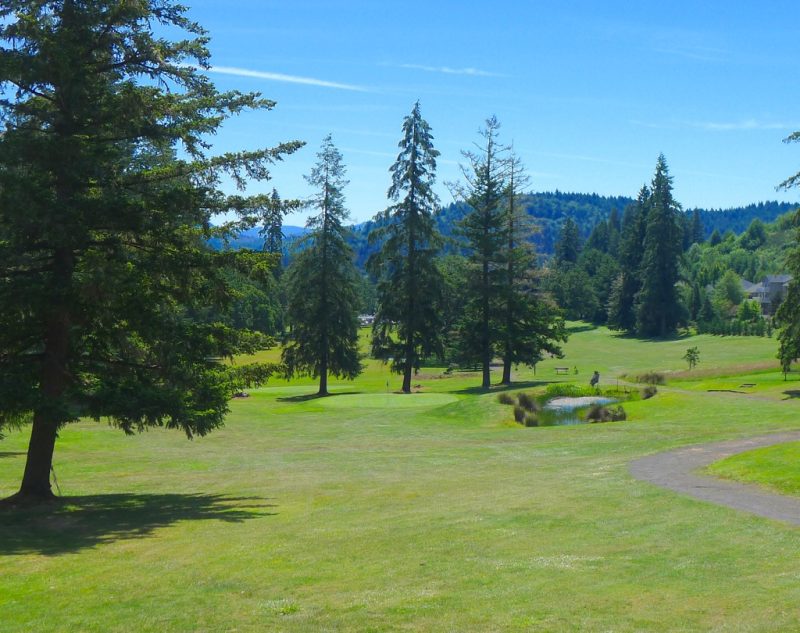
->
xmin=212 ymin=191 xmax=798 ymax=267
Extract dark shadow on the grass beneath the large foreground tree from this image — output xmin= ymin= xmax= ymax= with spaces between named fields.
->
xmin=0 ymin=494 xmax=276 ymax=556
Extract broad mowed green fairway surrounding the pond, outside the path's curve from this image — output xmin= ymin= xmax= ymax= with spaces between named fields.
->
xmin=0 ymin=328 xmax=800 ymax=633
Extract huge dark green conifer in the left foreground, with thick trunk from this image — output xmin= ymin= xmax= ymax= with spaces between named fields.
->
xmin=0 ymin=0 xmax=301 ymax=501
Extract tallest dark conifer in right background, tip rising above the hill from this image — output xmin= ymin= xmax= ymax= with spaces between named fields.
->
xmin=636 ymin=154 xmax=683 ymax=336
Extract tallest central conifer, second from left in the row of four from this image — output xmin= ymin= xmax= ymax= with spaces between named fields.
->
xmin=368 ymin=102 xmax=444 ymax=393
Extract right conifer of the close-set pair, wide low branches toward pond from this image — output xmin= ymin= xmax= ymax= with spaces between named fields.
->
xmin=498 ymin=150 xmax=567 ymax=385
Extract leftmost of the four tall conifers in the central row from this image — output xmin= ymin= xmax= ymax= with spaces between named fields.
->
xmin=283 ymin=135 xmax=361 ymax=396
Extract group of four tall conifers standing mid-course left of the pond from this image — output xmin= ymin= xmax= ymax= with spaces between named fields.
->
xmin=282 ymin=111 xmax=566 ymax=395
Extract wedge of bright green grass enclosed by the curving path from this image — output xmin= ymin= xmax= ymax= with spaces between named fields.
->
xmin=707 ymin=442 xmax=800 ymax=495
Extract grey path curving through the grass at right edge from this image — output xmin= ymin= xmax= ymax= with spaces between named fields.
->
xmin=630 ymin=431 xmax=800 ymax=525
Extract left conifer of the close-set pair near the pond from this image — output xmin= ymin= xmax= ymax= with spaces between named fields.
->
xmin=457 ymin=117 xmax=508 ymax=389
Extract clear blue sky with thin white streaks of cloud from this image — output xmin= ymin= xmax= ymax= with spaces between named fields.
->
xmin=187 ymin=0 xmax=800 ymax=224
